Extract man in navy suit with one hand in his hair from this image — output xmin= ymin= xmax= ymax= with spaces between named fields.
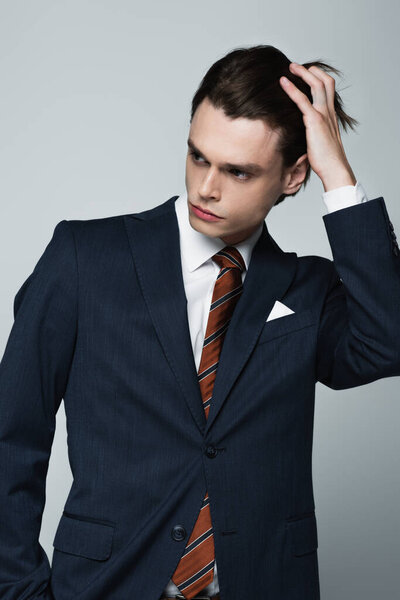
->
xmin=0 ymin=47 xmax=400 ymax=600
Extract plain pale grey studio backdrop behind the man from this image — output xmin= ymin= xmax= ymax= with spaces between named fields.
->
xmin=0 ymin=0 xmax=400 ymax=600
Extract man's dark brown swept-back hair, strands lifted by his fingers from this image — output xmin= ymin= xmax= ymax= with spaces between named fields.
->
xmin=190 ymin=45 xmax=359 ymax=206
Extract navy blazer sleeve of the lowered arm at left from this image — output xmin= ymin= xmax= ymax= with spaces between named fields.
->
xmin=0 ymin=220 xmax=78 ymax=600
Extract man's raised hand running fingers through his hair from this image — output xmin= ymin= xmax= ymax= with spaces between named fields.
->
xmin=279 ymin=63 xmax=357 ymax=192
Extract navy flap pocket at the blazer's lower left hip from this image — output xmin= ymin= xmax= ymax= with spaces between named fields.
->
xmin=53 ymin=513 xmax=115 ymax=561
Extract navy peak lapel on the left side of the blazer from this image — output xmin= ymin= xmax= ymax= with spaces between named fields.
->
xmin=124 ymin=196 xmax=206 ymax=432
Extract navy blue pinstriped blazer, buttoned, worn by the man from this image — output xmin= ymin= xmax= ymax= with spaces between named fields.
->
xmin=0 ymin=196 xmax=400 ymax=600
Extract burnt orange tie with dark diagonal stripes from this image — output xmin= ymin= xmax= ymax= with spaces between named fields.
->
xmin=172 ymin=246 xmax=246 ymax=600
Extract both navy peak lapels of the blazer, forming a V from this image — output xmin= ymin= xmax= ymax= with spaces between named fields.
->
xmin=124 ymin=196 xmax=297 ymax=435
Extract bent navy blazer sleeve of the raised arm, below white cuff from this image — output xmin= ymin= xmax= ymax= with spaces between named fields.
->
xmin=317 ymin=197 xmax=400 ymax=390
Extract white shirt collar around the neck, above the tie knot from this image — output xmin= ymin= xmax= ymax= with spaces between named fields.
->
xmin=175 ymin=192 xmax=263 ymax=272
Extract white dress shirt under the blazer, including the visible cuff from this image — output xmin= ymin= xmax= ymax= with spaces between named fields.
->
xmin=164 ymin=181 xmax=368 ymax=598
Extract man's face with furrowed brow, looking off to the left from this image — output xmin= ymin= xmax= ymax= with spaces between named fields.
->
xmin=185 ymin=98 xmax=301 ymax=245
